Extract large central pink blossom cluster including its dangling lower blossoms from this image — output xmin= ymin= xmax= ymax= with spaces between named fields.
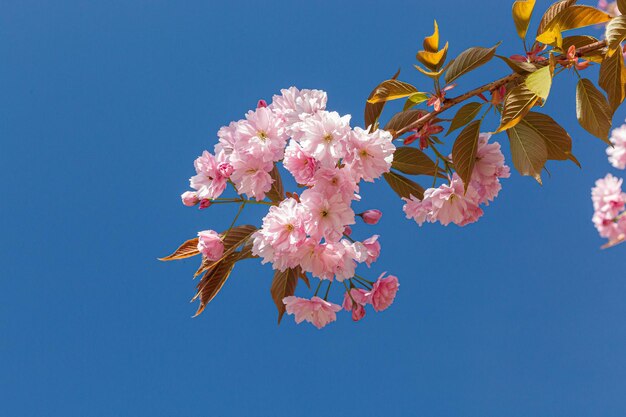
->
xmin=181 ymin=87 xmax=398 ymax=328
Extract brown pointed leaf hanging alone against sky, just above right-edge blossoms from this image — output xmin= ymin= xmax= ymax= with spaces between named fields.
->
xmin=576 ymin=78 xmax=611 ymax=145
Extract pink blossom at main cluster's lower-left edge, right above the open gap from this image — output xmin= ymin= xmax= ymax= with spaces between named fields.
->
xmin=230 ymin=152 xmax=274 ymax=201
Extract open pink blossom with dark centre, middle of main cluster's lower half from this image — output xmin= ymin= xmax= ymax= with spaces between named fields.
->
xmin=300 ymin=189 xmax=354 ymax=241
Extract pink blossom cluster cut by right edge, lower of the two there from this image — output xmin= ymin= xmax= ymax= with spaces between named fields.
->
xmin=591 ymin=174 xmax=626 ymax=243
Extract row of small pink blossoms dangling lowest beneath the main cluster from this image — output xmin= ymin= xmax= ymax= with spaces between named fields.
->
xmin=283 ymin=273 xmax=400 ymax=329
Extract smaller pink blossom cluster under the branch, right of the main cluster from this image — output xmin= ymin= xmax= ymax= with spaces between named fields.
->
xmin=403 ymin=133 xmax=510 ymax=226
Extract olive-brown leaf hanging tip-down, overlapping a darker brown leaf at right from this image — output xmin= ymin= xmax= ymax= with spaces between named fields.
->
xmin=506 ymin=118 xmax=548 ymax=184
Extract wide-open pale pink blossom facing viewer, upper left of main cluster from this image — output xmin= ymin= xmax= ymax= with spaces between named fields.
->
xmin=235 ymin=107 xmax=287 ymax=162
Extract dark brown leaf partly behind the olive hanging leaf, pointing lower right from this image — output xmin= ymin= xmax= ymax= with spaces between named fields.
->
xmin=520 ymin=111 xmax=580 ymax=167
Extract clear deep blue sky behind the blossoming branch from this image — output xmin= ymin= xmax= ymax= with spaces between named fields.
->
xmin=0 ymin=0 xmax=626 ymax=417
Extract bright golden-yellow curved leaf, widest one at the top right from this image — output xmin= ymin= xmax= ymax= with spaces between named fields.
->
xmin=537 ymin=6 xmax=611 ymax=47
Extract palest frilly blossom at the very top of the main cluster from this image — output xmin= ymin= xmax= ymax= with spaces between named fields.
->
xmin=270 ymin=87 xmax=327 ymax=125
